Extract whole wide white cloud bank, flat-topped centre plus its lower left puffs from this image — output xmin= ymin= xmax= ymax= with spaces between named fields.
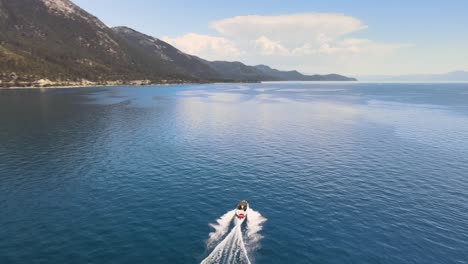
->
xmin=163 ymin=13 xmax=407 ymax=73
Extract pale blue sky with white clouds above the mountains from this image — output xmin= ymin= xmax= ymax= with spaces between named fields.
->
xmin=72 ymin=0 xmax=468 ymax=76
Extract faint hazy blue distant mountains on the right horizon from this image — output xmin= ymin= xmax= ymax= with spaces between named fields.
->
xmin=360 ymin=71 xmax=468 ymax=82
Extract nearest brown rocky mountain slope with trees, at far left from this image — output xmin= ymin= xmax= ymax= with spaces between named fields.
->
xmin=0 ymin=0 xmax=205 ymax=84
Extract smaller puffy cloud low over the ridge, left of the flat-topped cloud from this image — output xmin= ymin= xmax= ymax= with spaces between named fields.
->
xmin=162 ymin=33 xmax=242 ymax=60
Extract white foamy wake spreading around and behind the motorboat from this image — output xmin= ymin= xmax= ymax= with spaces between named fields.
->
xmin=201 ymin=208 xmax=267 ymax=264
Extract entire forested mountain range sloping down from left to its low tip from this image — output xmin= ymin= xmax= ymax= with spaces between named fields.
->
xmin=0 ymin=0 xmax=355 ymax=86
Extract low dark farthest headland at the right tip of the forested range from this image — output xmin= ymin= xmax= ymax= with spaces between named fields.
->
xmin=255 ymin=65 xmax=357 ymax=81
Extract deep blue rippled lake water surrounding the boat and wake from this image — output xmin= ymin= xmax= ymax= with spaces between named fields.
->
xmin=0 ymin=83 xmax=468 ymax=264
